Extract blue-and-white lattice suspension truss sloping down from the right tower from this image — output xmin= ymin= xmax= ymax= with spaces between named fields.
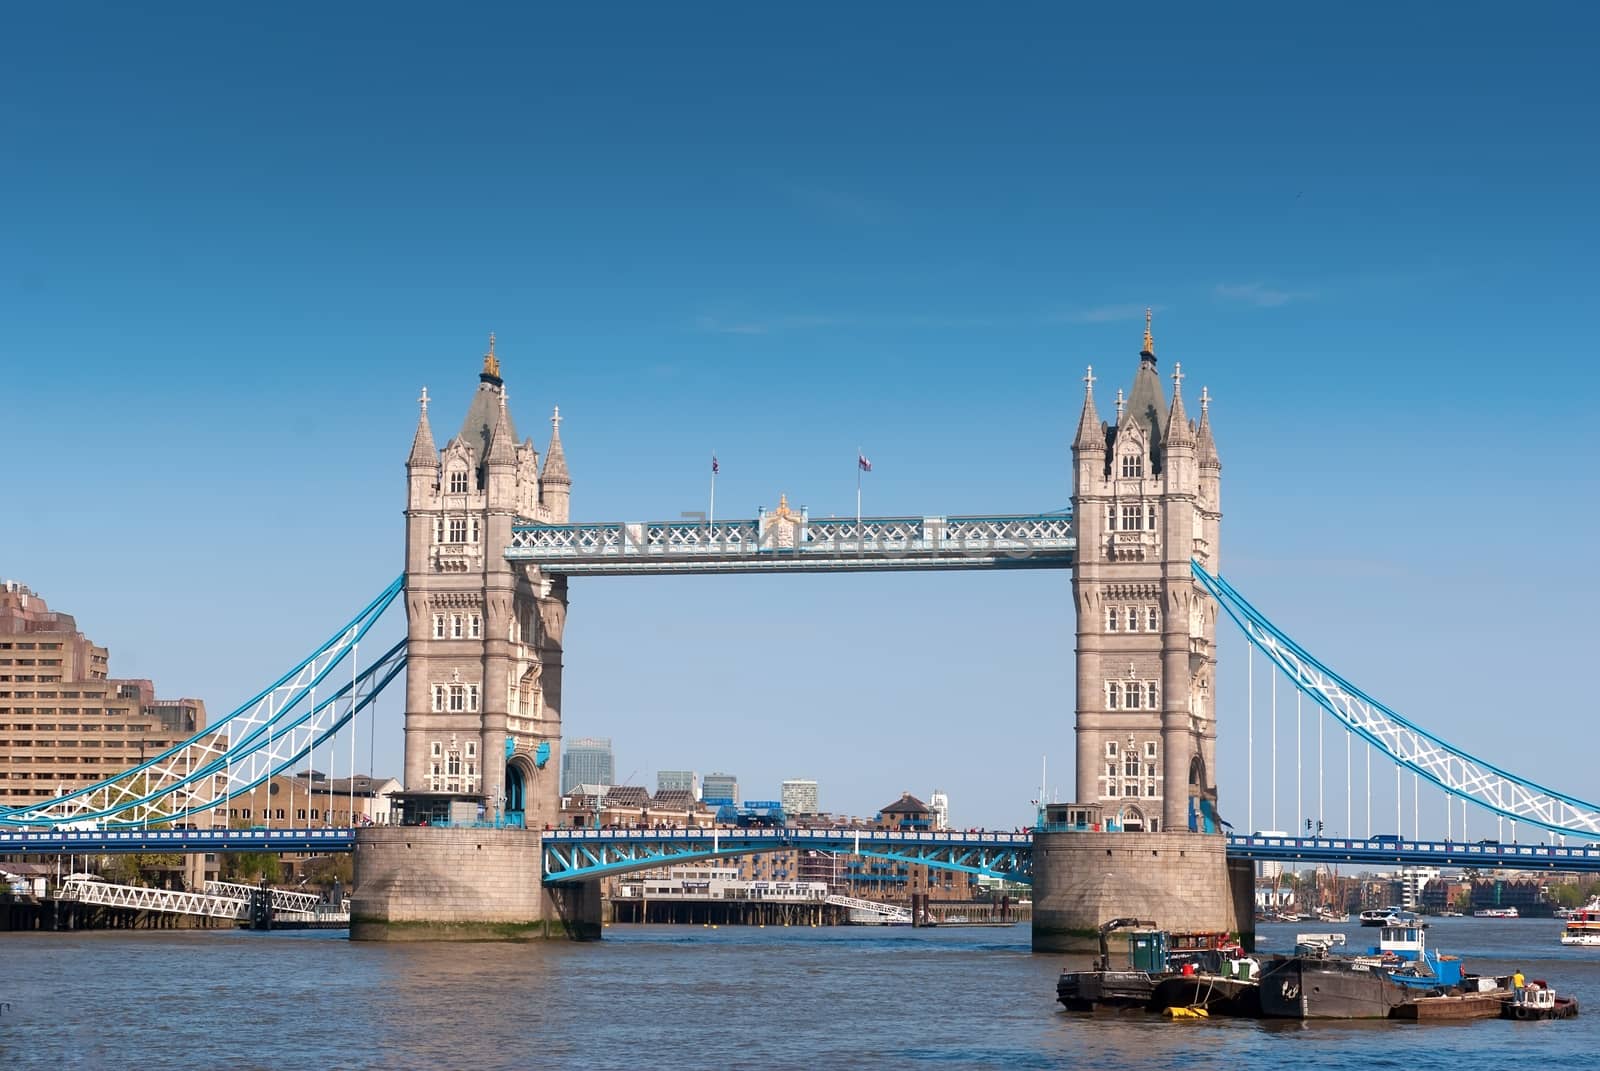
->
xmin=1194 ymin=564 xmax=1600 ymax=837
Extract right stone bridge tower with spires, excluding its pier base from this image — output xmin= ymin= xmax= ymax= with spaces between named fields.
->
xmin=1072 ymin=312 xmax=1222 ymax=832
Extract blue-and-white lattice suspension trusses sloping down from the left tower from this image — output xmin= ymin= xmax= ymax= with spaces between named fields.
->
xmin=0 ymin=581 xmax=405 ymax=826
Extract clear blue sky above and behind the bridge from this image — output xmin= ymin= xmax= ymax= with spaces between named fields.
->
xmin=0 ymin=3 xmax=1600 ymax=834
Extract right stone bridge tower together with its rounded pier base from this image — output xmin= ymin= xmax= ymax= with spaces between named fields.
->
xmin=1034 ymin=312 xmax=1254 ymax=951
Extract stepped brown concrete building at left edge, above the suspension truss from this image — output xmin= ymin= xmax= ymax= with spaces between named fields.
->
xmin=0 ymin=581 xmax=206 ymax=807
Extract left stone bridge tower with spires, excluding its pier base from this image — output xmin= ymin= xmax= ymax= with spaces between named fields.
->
xmin=405 ymin=335 xmax=571 ymax=829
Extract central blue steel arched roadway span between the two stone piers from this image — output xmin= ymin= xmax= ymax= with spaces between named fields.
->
xmin=544 ymin=829 xmax=1032 ymax=884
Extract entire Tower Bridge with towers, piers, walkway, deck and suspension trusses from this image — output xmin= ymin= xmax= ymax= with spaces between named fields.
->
xmin=0 ymin=315 xmax=1600 ymax=948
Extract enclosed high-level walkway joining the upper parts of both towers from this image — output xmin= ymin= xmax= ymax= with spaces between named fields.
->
xmin=506 ymin=512 xmax=1078 ymax=576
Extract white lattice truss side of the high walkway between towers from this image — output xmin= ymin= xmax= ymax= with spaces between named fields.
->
xmin=506 ymin=514 xmax=1077 ymax=572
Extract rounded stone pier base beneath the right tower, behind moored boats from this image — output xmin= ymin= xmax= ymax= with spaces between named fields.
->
xmin=1034 ymin=832 xmax=1254 ymax=953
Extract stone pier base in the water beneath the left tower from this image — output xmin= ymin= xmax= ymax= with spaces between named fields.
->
xmin=350 ymin=826 xmax=600 ymax=941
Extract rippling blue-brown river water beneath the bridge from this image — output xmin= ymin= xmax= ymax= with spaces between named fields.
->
xmin=0 ymin=919 xmax=1600 ymax=1071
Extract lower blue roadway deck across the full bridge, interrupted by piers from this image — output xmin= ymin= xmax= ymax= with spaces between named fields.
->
xmin=0 ymin=826 xmax=1600 ymax=880
